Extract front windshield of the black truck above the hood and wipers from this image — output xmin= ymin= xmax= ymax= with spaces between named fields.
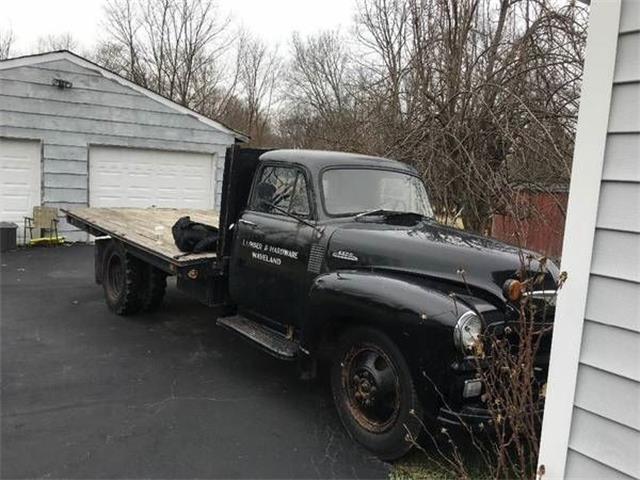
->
xmin=322 ymin=168 xmax=433 ymax=217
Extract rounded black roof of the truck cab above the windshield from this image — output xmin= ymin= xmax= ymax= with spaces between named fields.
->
xmin=260 ymin=149 xmax=417 ymax=175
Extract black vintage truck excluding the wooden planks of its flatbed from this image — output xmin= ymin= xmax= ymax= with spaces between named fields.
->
xmin=68 ymin=148 xmax=559 ymax=459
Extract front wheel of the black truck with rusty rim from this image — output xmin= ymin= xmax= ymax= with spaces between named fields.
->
xmin=331 ymin=327 xmax=423 ymax=461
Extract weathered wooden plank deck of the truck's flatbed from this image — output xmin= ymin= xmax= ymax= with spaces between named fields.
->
xmin=63 ymin=208 xmax=219 ymax=265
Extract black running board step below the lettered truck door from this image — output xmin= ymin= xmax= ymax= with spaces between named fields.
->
xmin=216 ymin=315 xmax=299 ymax=360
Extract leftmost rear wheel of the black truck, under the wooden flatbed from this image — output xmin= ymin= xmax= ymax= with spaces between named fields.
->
xmin=102 ymin=241 xmax=144 ymax=315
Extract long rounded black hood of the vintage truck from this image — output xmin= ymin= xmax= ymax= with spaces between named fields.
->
xmin=328 ymin=220 xmax=558 ymax=301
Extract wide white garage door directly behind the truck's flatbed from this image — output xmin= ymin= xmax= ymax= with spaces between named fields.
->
xmin=89 ymin=147 xmax=215 ymax=208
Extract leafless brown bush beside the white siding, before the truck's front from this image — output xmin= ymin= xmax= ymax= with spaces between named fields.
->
xmin=411 ymin=240 xmax=566 ymax=480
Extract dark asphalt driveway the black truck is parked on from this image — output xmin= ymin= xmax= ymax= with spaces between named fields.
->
xmin=0 ymin=246 xmax=388 ymax=478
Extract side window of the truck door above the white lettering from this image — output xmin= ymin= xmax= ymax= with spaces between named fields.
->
xmin=251 ymin=167 xmax=309 ymax=215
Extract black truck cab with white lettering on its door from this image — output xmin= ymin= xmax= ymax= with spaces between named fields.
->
xmin=229 ymin=150 xmax=432 ymax=331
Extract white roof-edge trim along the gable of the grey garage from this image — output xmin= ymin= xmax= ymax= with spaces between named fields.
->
xmin=0 ymin=50 xmax=249 ymax=142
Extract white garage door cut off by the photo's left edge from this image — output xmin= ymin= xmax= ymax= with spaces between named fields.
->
xmin=0 ymin=138 xmax=41 ymax=236
